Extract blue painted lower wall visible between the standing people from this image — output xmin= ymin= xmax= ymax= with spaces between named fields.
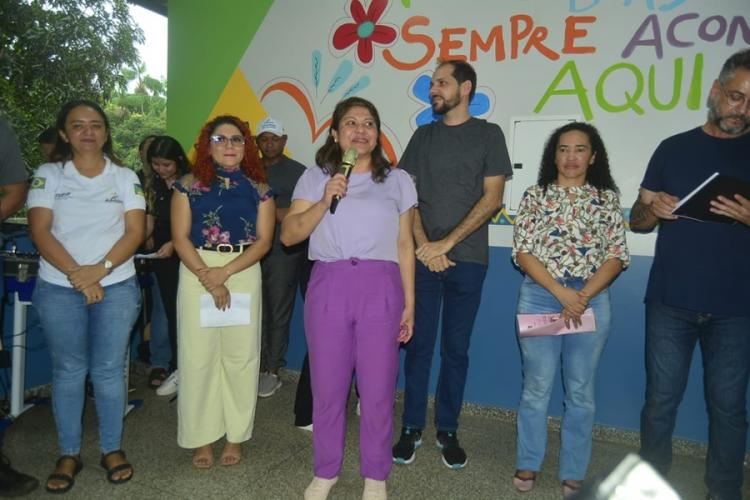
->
xmin=287 ymin=247 xmax=750 ymax=452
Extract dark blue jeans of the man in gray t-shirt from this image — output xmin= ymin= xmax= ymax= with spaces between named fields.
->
xmin=402 ymin=261 xmax=487 ymax=431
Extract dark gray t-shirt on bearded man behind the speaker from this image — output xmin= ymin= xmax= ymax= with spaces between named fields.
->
xmin=398 ymin=118 xmax=513 ymax=265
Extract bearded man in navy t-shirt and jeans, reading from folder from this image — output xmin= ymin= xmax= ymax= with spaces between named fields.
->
xmin=630 ymin=49 xmax=750 ymax=500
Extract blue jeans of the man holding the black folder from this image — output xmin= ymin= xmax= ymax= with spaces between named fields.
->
xmin=640 ymin=301 xmax=750 ymax=500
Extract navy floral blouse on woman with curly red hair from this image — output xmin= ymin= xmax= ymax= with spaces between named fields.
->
xmin=175 ymin=167 xmax=273 ymax=247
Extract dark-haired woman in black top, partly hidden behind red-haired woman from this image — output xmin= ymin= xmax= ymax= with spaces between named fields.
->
xmin=145 ymin=135 xmax=190 ymax=395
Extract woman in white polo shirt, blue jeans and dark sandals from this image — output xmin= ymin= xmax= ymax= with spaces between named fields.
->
xmin=28 ymin=100 xmax=145 ymax=493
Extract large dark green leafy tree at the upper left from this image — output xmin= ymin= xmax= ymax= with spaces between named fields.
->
xmin=0 ymin=0 xmax=143 ymax=167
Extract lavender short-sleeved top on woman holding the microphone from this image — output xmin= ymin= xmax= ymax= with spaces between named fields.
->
xmin=292 ymin=166 xmax=417 ymax=263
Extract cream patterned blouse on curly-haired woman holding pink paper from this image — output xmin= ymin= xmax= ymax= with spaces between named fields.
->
xmin=512 ymin=184 xmax=630 ymax=279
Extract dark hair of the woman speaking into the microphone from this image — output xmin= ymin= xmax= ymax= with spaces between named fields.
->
xmin=315 ymin=97 xmax=391 ymax=182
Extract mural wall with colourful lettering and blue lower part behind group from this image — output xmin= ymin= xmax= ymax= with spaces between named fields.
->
xmin=168 ymin=0 xmax=750 ymax=450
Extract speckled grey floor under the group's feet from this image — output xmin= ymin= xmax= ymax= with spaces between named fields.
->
xmin=5 ymin=374 xmax=750 ymax=500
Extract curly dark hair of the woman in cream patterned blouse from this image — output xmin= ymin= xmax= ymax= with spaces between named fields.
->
xmin=537 ymin=122 xmax=620 ymax=193
